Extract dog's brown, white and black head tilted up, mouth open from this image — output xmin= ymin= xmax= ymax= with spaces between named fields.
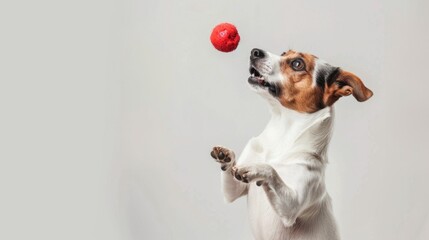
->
xmin=248 ymin=48 xmax=373 ymax=113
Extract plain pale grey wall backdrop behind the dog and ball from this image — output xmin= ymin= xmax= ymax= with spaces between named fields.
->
xmin=0 ymin=0 xmax=429 ymax=240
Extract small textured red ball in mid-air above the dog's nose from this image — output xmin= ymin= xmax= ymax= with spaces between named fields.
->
xmin=210 ymin=23 xmax=240 ymax=52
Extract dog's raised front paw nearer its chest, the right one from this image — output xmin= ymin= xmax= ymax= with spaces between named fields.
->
xmin=232 ymin=163 xmax=274 ymax=186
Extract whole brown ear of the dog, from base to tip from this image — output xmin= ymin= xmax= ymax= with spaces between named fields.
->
xmin=323 ymin=70 xmax=373 ymax=106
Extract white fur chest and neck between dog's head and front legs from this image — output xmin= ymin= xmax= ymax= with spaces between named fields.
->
xmin=238 ymin=108 xmax=333 ymax=166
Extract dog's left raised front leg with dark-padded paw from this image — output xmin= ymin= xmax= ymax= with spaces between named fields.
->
xmin=210 ymin=146 xmax=247 ymax=202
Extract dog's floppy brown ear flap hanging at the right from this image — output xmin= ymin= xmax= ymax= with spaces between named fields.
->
xmin=332 ymin=70 xmax=373 ymax=102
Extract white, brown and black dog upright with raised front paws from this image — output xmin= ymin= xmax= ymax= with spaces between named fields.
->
xmin=210 ymin=48 xmax=373 ymax=240
